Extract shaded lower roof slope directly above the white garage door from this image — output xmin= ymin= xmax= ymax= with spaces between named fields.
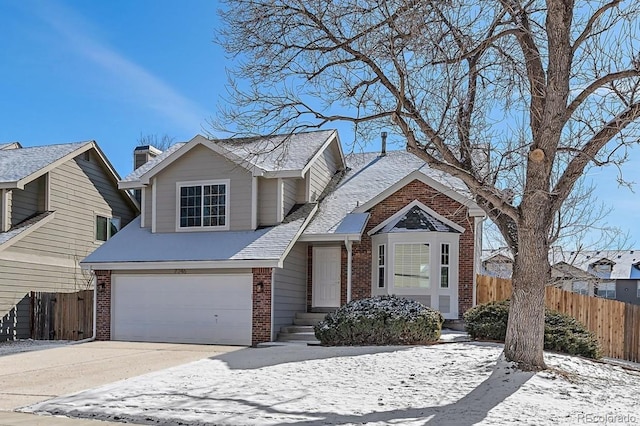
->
xmin=81 ymin=209 xmax=312 ymax=265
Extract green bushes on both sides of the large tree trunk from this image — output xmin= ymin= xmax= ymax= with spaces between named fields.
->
xmin=464 ymin=300 xmax=601 ymax=359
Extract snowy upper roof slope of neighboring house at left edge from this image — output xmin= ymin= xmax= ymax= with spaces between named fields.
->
xmin=0 ymin=141 xmax=91 ymax=183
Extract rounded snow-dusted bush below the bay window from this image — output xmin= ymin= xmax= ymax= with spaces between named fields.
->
xmin=314 ymin=296 xmax=444 ymax=346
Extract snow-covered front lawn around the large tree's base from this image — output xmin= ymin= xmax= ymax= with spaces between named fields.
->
xmin=25 ymin=343 xmax=640 ymax=426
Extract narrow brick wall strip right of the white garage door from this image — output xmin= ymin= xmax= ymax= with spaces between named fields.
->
xmin=251 ymin=268 xmax=272 ymax=346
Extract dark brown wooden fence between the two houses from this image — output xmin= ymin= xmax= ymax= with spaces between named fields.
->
xmin=31 ymin=290 xmax=93 ymax=340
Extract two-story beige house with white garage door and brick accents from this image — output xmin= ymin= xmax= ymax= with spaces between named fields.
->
xmin=82 ymin=131 xmax=484 ymax=345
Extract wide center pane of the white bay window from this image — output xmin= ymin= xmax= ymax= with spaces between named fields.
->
xmin=393 ymin=244 xmax=430 ymax=288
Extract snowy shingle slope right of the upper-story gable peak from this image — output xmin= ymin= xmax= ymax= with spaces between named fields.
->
xmin=214 ymin=130 xmax=336 ymax=172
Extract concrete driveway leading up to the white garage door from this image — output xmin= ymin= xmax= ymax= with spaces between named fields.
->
xmin=0 ymin=342 xmax=242 ymax=425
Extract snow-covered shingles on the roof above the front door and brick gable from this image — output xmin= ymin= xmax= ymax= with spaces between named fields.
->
xmin=304 ymin=151 xmax=468 ymax=236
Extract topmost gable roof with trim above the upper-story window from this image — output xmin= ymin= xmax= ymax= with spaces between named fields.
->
xmin=119 ymin=130 xmax=344 ymax=189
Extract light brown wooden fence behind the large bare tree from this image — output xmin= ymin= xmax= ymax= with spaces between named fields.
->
xmin=476 ymin=275 xmax=640 ymax=362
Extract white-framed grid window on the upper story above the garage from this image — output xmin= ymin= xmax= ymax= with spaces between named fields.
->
xmin=178 ymin=180 xmax=229 ymax=229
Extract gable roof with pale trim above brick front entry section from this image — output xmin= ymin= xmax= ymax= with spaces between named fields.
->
xmin=303 ymin=151 xmax=484 ymax=240
